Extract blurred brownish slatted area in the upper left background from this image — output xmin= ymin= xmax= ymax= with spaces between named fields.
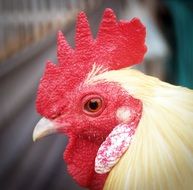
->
xmin=0 ymin=0 xmax=100 ymax=61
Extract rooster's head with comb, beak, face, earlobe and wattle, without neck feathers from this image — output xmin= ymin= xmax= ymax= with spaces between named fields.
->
xmin=33 ymin=9 xmax=146 ymax=190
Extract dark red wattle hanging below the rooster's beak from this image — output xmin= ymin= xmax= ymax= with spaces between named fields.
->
xmin=64 ymin=137 xmax=108 ymax=190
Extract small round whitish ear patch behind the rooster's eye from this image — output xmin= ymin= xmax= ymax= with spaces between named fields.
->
xmin=116 ymin=106 xmax=131 ymax=123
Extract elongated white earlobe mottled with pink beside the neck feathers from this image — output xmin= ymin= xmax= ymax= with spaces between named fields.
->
xmin=95 ymin=124 xmax=135 ymax=174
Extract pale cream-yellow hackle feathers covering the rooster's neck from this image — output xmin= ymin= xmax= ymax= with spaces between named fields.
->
xmin=87 ymin=68 xmax=193 ymax=190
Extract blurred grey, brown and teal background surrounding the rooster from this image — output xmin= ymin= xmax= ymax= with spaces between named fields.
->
xmin=0 ymin=0 xmax=193 ymax=190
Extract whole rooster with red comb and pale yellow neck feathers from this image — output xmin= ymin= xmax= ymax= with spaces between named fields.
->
xmin=33 ymin=9 xmax=193 ymax=190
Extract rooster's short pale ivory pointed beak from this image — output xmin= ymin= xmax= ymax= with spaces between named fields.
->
xmin=33 ymin=117 xmax=58 ymax=141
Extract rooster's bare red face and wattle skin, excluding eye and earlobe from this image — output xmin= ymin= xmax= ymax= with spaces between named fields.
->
xmin=40 ymin=83 xmax=142 ymax=190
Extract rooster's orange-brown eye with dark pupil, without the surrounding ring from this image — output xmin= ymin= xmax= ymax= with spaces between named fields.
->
xmin=84 ymin=98 xmax=102 ymax=113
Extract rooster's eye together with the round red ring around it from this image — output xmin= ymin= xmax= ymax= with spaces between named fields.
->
xmin=82 ymin=95 xmax=104 ymax=116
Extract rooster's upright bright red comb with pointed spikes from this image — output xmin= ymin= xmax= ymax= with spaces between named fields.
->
xmin=37 ymin=9 xmax=146 ymax=116
